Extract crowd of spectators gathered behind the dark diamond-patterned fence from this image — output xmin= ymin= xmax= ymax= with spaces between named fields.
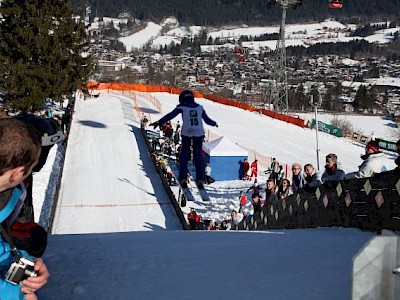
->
xmin=148 ymin=124 xmax=400 ymax=230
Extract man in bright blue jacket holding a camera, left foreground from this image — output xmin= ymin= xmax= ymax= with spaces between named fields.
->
xmin=0 ymin=118 xmax=49 ymax=300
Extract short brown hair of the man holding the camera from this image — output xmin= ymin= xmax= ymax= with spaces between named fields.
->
xmin=0 ymin=118 xmax=41 ymax=176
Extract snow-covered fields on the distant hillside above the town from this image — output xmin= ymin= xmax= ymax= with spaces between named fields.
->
xmin=110 ymin=18 xmax=400 ymax=51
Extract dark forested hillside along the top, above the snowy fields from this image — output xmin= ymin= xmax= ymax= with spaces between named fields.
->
xmin=71 ymin=0 xmax=400 ymax=27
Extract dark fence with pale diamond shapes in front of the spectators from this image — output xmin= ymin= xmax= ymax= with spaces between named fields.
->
xmin=237 ymin=171 xmax=400 ymax=232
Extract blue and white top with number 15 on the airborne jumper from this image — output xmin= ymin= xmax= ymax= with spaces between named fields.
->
xmin=158 ymin=101 xmax=217 ymax=137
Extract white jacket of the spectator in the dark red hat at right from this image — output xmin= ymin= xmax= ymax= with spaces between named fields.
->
xmin=345 ymin=152 xmax=390 ymax=179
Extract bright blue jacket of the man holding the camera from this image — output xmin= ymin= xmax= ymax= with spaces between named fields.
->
xmin=0 ymin=187 xmax=33 ymax=300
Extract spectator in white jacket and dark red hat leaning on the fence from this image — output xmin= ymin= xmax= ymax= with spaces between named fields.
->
xmin=345 ymin=140 xmax=389 ymax=179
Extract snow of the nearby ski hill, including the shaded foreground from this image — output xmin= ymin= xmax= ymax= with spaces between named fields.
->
xmin=28 ymin=91 xmax=394 ymax=299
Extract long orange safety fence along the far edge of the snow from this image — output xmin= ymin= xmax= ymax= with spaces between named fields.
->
xmin=83 ymin=82 xmax=305 ymax=128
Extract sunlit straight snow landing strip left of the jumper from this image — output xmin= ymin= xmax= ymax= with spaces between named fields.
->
xmin=53 ymin=95 xmax=181 ymax=234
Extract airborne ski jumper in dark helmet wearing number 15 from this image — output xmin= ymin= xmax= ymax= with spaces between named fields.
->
xmin=150 ymin=90 xmax=218 ymax=188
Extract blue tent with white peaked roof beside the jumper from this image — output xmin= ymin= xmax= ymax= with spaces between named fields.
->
xmin=203 ymin=136 xmax=248 ymax=180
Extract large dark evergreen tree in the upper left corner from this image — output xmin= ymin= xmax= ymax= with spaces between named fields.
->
xmin=0 ymin=0 xmax=92 ymax=111
